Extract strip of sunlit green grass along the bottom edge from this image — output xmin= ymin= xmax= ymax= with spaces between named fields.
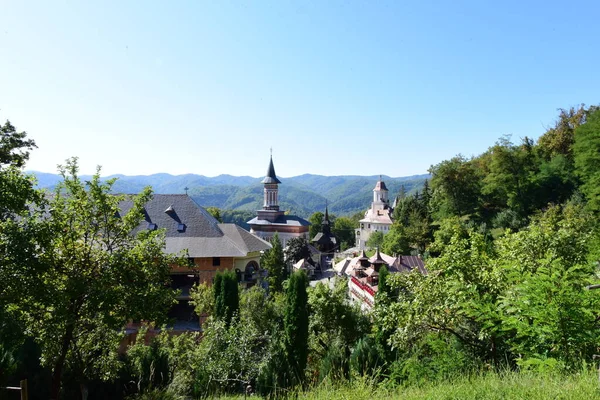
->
xmin=220 ymin=371 xmax=600 ymax=400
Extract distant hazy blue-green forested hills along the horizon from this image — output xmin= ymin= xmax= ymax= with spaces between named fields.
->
xmin=32 ymin=172 xmax=428 ymax=218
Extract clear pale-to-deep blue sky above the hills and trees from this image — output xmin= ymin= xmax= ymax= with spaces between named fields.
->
xmin=0 ymin=0 xmax=600 ymax=177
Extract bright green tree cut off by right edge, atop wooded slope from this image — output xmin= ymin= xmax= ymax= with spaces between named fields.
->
xmin=574 ymin=108 xmax=600 ymax=211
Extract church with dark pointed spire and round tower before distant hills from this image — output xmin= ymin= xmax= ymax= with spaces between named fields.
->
xmin=248 ymin=155 xmax=310 ymax=247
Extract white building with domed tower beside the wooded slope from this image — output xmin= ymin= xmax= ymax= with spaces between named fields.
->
xmin=356 ymin=176 xmax=393 ymax=250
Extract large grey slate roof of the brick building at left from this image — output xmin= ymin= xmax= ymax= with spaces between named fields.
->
xmin=122 ymin=194 xmax=271 ymax=257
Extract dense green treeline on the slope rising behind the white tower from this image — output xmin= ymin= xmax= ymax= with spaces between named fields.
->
xmin=382 ymin=105 xmax=600 ymax=255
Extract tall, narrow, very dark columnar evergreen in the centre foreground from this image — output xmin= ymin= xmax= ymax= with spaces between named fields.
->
xmin=283 ymin=271 xmax=308 ymax=382
